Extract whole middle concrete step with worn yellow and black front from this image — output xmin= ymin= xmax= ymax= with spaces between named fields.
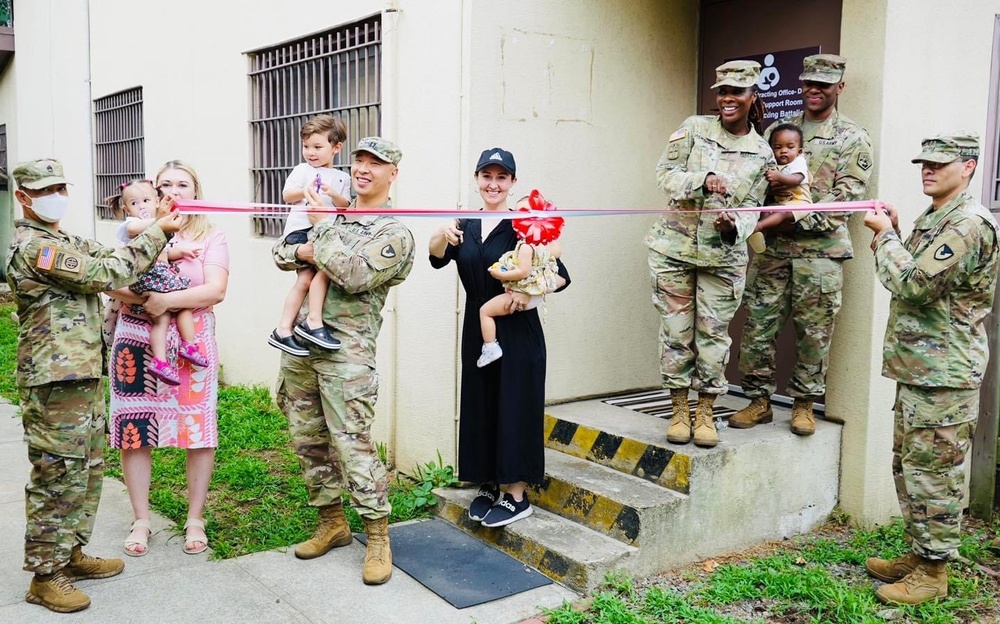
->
xmin=529 ymin=449 xmax=686 ymax=546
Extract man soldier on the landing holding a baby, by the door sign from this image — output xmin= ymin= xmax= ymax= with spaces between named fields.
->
xmin=729 ymin=54 xmax=874 ymax=435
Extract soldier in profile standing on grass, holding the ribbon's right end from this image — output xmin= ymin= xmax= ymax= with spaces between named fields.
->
xmin=865 ymin=134 xmax=1000 ymax=604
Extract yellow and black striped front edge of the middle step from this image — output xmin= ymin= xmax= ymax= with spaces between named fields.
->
xmin=529 ymin=475 xmax=640 ymax=546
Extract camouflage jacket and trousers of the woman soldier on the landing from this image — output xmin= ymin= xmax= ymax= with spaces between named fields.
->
xmin=645 ymin=116 xmax=775 ymax=394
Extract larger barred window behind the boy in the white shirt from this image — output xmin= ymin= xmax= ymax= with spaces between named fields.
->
xmin=247 ymin=15 xmax=382 ymax=237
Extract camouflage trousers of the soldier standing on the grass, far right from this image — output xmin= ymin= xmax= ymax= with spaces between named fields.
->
xmin=892 ymin=384 xmax=979 ymax=560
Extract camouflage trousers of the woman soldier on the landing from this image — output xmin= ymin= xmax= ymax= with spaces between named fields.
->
xmin=649 ymin=251 xmax=746 ymax=394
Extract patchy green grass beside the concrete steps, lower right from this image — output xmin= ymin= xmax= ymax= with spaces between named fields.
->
xmin=546 ymin=520 xmax=998 ymax=624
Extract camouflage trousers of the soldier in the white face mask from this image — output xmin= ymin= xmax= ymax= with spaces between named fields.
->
xmin=19 ymin=379 xmax=107 ymax=574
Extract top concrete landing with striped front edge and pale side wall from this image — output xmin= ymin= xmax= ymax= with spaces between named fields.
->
xmin=545 ymin=396 xmax=842 ymax=576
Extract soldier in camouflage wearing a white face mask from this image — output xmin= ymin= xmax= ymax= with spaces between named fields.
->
xmin=6 ymin=159 xmax=180 ymax=613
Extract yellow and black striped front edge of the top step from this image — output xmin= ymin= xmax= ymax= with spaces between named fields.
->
xmin=545 ymin=414 xmax=691 ymax=494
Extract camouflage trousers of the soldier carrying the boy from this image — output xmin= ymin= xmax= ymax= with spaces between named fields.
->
xmin=276 ymin=355 xmax=392 ymax=520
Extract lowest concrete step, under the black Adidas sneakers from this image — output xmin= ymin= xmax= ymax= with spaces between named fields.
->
xmin=434 ymin=488 xmax=637 ymax=593
